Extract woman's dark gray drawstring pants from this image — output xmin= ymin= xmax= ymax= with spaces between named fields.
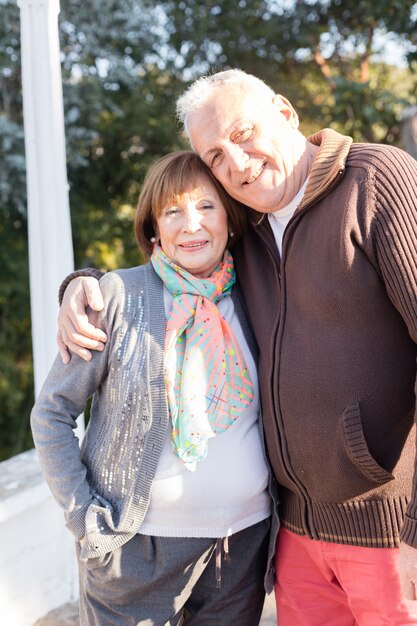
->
xmin=78 ymin=519 xmax=270 ymax=626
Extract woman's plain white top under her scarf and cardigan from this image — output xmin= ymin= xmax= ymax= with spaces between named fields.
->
xmin=139 ymin=287 xmax=271 ymax=538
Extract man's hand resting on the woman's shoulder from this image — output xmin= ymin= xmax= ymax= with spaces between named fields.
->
xmin=57 ymin=276 xmax=107 ymax=364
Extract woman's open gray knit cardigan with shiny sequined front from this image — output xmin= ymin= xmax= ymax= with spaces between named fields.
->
xmin=31 ymin=264 xmax=278 ymax=591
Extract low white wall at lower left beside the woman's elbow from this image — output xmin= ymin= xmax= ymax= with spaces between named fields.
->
xmin=0 ymin=450 xmax=78 ymax=626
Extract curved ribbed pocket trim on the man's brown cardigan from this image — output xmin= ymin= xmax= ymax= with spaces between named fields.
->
xmin=342 ymin=403 xmax=395 ymax=485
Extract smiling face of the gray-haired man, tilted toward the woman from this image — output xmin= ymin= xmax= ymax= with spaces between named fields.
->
xmin=189 ymin=85 xmax=309 ymax=213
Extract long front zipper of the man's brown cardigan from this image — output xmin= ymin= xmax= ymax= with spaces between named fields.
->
xmin=259 ymin=168 xmax=345 ymax=539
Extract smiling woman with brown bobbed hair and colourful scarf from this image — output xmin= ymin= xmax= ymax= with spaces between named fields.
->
xmin=31 ymin=152 xmax=276 ymax=626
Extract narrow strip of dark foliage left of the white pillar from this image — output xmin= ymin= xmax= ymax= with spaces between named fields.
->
xmin=0 ymin=3 xmax=33 ymax=458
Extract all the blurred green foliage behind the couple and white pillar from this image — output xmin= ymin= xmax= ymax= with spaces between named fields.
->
xmin=0 ymin=0 xmax=417 ymax=458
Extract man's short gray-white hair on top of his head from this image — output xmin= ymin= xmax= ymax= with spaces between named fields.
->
xmin=177 ymin=69 xmax=275 ymax=136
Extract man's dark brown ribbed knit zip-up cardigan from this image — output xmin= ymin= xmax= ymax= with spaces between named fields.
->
xmin=234 ymin=130 xmax=417 ymax=547
